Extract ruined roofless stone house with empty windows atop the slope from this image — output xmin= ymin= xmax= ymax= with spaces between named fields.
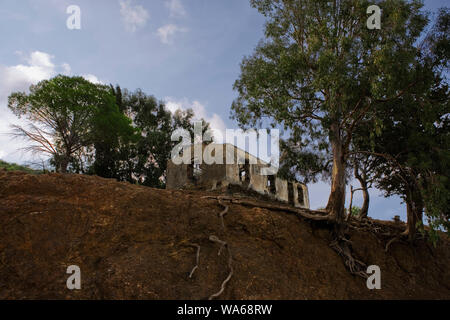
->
xmin=166 ymin=144 xmax=309 ymax=209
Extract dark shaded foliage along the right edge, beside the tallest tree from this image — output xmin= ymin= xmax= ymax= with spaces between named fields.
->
xmin=354 ymin=10 xmax=450 ymax=238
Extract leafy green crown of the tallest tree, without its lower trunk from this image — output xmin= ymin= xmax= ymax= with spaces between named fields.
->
xmin=232 ymin=0 xmax=427 ymax=130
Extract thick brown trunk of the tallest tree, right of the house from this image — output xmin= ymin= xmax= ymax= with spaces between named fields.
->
xmin=327 ymin=124 xmax=346 ymax=224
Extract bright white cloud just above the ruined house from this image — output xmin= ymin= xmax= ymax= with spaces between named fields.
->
xmin=164 ymin=97 xmax=226 ymax=143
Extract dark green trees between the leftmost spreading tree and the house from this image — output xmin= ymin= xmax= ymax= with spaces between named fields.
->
xmin=90 ymin=86 xmax=209 ymax=188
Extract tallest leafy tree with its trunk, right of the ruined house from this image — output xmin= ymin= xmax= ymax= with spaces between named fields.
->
xmin=232 ymin=0 xmax=445 ymax=238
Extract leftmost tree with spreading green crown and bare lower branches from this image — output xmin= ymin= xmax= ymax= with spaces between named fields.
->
xmin=8 ymin=75 xmax=131 ymax=173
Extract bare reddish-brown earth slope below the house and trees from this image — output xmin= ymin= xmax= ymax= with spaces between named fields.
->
xmin=0 ymin=171 xmax=450 ymax=299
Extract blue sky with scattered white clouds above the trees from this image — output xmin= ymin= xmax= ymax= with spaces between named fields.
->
xmin=0 ymin=0 xmax=447 ymax=219
